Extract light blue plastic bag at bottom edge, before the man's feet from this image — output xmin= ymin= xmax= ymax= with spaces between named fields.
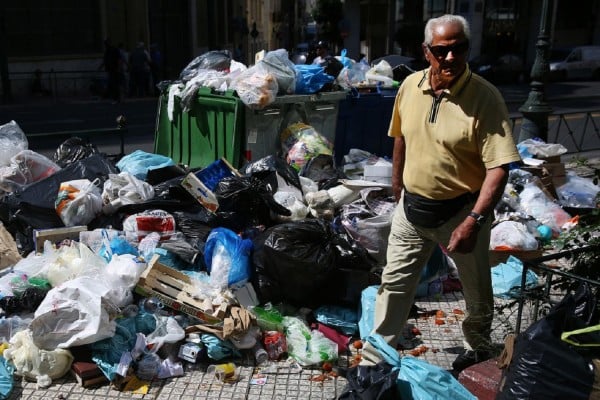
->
xmin=367 ymin=334 xmax=477 ymax=400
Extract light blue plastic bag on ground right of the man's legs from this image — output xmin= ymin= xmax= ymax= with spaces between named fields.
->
xmin=491 ymin=256 xmax=538 ymax=299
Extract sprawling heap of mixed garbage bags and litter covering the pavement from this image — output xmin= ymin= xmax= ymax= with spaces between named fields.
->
xmin=0 ymin=90 xmax=598 ymax=391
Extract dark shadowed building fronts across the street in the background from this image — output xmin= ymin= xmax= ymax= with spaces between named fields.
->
xmin=0 ymin=0 xmax=600 ymax=101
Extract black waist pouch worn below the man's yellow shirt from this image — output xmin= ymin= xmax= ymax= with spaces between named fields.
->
xmin=404 ymin=189 xmax=478 ymax=228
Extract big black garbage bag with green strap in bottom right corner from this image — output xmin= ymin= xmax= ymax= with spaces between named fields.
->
xmin=496 ymin=284 xmax=600 ymax=400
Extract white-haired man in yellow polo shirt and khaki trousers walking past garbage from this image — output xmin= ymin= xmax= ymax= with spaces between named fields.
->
xmin=361 ymin=15 xmax=520 ymax=372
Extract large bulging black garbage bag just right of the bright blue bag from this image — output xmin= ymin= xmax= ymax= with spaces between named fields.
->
xmin=252 ymin=219 xmax=336 ymax=307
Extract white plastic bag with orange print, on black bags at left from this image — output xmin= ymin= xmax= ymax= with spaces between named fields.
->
xmin=56 ymin=179 xmax=102 ymax=226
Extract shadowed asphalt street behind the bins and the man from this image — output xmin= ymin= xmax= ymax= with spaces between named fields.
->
xmin=0 ymin=81 xmax=600 ymax=160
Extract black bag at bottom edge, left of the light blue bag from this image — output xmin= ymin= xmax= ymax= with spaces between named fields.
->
xmin=338 ymin=362 xmax=400 ymax=400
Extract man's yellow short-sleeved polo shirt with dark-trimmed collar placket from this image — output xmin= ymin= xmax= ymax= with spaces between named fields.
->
xmin=388 ymin=66 xmax=521 ymax=200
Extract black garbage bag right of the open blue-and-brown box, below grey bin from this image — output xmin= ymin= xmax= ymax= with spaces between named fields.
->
xmin=214 ymin=176 xmax=291 ymax=232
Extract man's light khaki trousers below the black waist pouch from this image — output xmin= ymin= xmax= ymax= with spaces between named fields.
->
xmin=361 ymin=195 xmax=494 ymax=365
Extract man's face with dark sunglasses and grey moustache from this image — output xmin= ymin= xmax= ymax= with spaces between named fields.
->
xmin=423 ymin=24 xmax=469 ymax=89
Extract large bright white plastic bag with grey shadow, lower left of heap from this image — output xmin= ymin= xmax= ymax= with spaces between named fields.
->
xmin=29 ymin=276 xmax=116 ymax=349
